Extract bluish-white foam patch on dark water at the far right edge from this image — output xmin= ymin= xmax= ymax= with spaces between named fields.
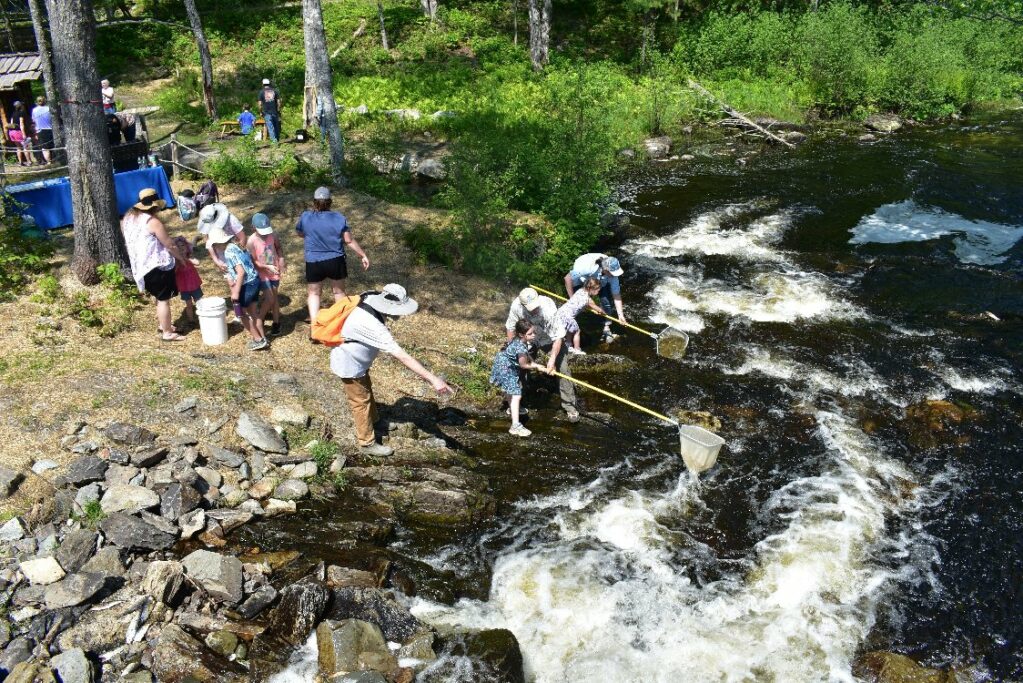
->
xmin=849 ymin=199 xmax=1023 ymax=266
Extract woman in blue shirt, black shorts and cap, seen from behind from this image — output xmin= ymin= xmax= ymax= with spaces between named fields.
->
xmin=295 ymin=187 xmax=369 ymax=331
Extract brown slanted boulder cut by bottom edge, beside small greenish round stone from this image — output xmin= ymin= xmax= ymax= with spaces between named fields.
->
xmin=152 ymin=624 xmax=249 ymax=683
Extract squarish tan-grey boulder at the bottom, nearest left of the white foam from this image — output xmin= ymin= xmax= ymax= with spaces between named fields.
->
xmin=316 ymin=619 xmax=398 ymax=680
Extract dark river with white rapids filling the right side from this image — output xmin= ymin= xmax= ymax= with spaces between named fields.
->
xmin=257 ymin=111 xmax=1023 ymax=683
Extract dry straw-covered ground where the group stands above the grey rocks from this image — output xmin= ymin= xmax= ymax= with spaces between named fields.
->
xmin=0 ymin=184 xmax=514 ymax=509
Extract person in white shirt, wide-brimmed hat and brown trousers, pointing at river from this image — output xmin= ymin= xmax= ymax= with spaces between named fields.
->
xmin=330 ymin=284 xmax=453 ymax=455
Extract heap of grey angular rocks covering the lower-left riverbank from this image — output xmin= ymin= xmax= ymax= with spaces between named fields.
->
xmin=0 ymin=401 xmax=522 ymax=683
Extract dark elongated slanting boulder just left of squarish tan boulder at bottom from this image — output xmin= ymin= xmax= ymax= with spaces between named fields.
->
xmin=249 ymin=577 xmax=330 ymax=681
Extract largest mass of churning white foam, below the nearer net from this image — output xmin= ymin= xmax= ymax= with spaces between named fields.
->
xmin=413 ymin=412 xmax=908 ymax=683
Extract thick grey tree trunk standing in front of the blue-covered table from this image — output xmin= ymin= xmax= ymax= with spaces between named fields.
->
xmin=48 ymin=0 xmax=128 ymax=284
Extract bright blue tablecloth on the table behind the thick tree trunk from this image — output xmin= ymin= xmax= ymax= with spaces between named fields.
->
xmin=6 ymin=166 xmax=174 ymax=230
